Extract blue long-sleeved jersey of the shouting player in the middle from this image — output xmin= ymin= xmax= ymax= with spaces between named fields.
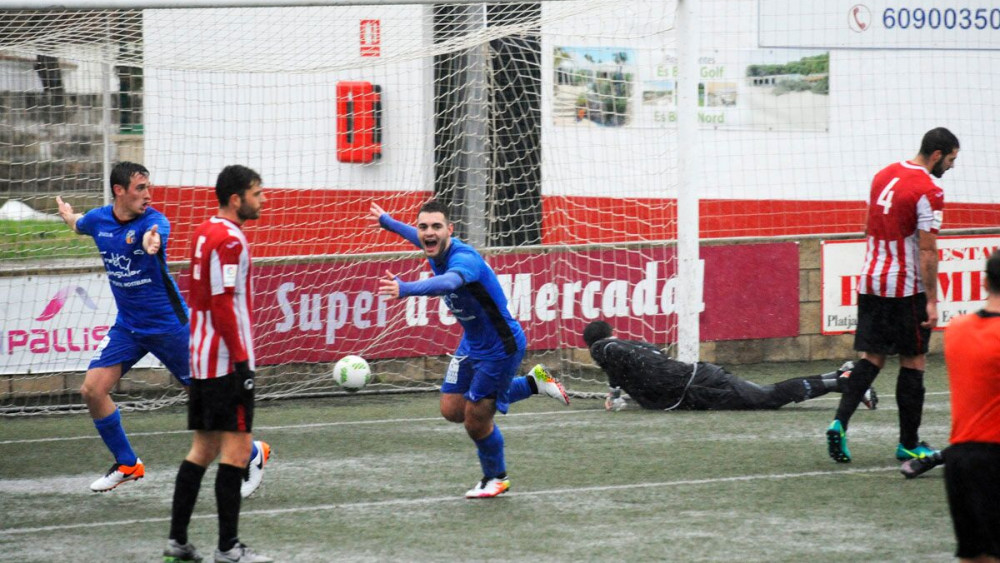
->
xmin=379 ymin=214 xmax=528 ymax=360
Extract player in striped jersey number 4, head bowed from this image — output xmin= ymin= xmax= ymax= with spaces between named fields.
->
xmin=826 ymin=127 xmax=959 ymax=463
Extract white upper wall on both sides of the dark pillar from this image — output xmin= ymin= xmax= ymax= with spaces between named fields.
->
xmin=131 ymin=0 xmax=1000 ymax=202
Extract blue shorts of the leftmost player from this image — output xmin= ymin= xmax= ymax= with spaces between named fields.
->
xmin=88 ymin=323 xmax=191 ymax=387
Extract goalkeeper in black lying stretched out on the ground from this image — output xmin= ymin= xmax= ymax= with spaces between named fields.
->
xmin=583 ymin=321 xmax=878 ymax=410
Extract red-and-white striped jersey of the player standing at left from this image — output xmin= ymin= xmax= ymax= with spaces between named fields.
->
xmin=188 ymin=217 xmax=255 ymax=379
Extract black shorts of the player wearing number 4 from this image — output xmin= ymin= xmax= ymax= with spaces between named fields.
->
xmin=854 ymin=293 xmax=931 ymax=356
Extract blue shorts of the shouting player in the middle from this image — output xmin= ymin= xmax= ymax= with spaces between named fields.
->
xmin=441 ymin=350 xmax=524 ymax=414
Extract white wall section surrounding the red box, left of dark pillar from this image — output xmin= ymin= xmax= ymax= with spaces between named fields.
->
xmin=144 ymin=6 xmax=433 ymax=190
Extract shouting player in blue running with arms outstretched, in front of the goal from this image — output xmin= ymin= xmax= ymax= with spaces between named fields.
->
xmin=371 ymin=199 xmax=569 ymax=498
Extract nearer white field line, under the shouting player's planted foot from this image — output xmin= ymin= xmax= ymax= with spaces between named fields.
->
xmin=0 ymin=468 xmax=899 ymax=536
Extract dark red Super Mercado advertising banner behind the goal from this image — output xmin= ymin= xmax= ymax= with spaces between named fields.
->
xmin=179 ymin=243 xmax=799 ymax=364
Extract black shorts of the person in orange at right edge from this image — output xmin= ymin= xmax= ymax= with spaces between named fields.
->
xmin=944 ymin=442 xmax=1000 ymax=558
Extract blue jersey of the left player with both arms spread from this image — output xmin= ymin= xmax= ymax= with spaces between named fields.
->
xmin=76 ymin=205 xmax=188 ymax=334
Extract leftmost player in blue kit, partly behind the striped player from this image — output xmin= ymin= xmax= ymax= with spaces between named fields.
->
xmin=56 ymin=162 xmax=269 ymax=496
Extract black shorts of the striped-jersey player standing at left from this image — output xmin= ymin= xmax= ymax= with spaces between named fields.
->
xmin=188 ymin=373 xmax=254 ymax=432
